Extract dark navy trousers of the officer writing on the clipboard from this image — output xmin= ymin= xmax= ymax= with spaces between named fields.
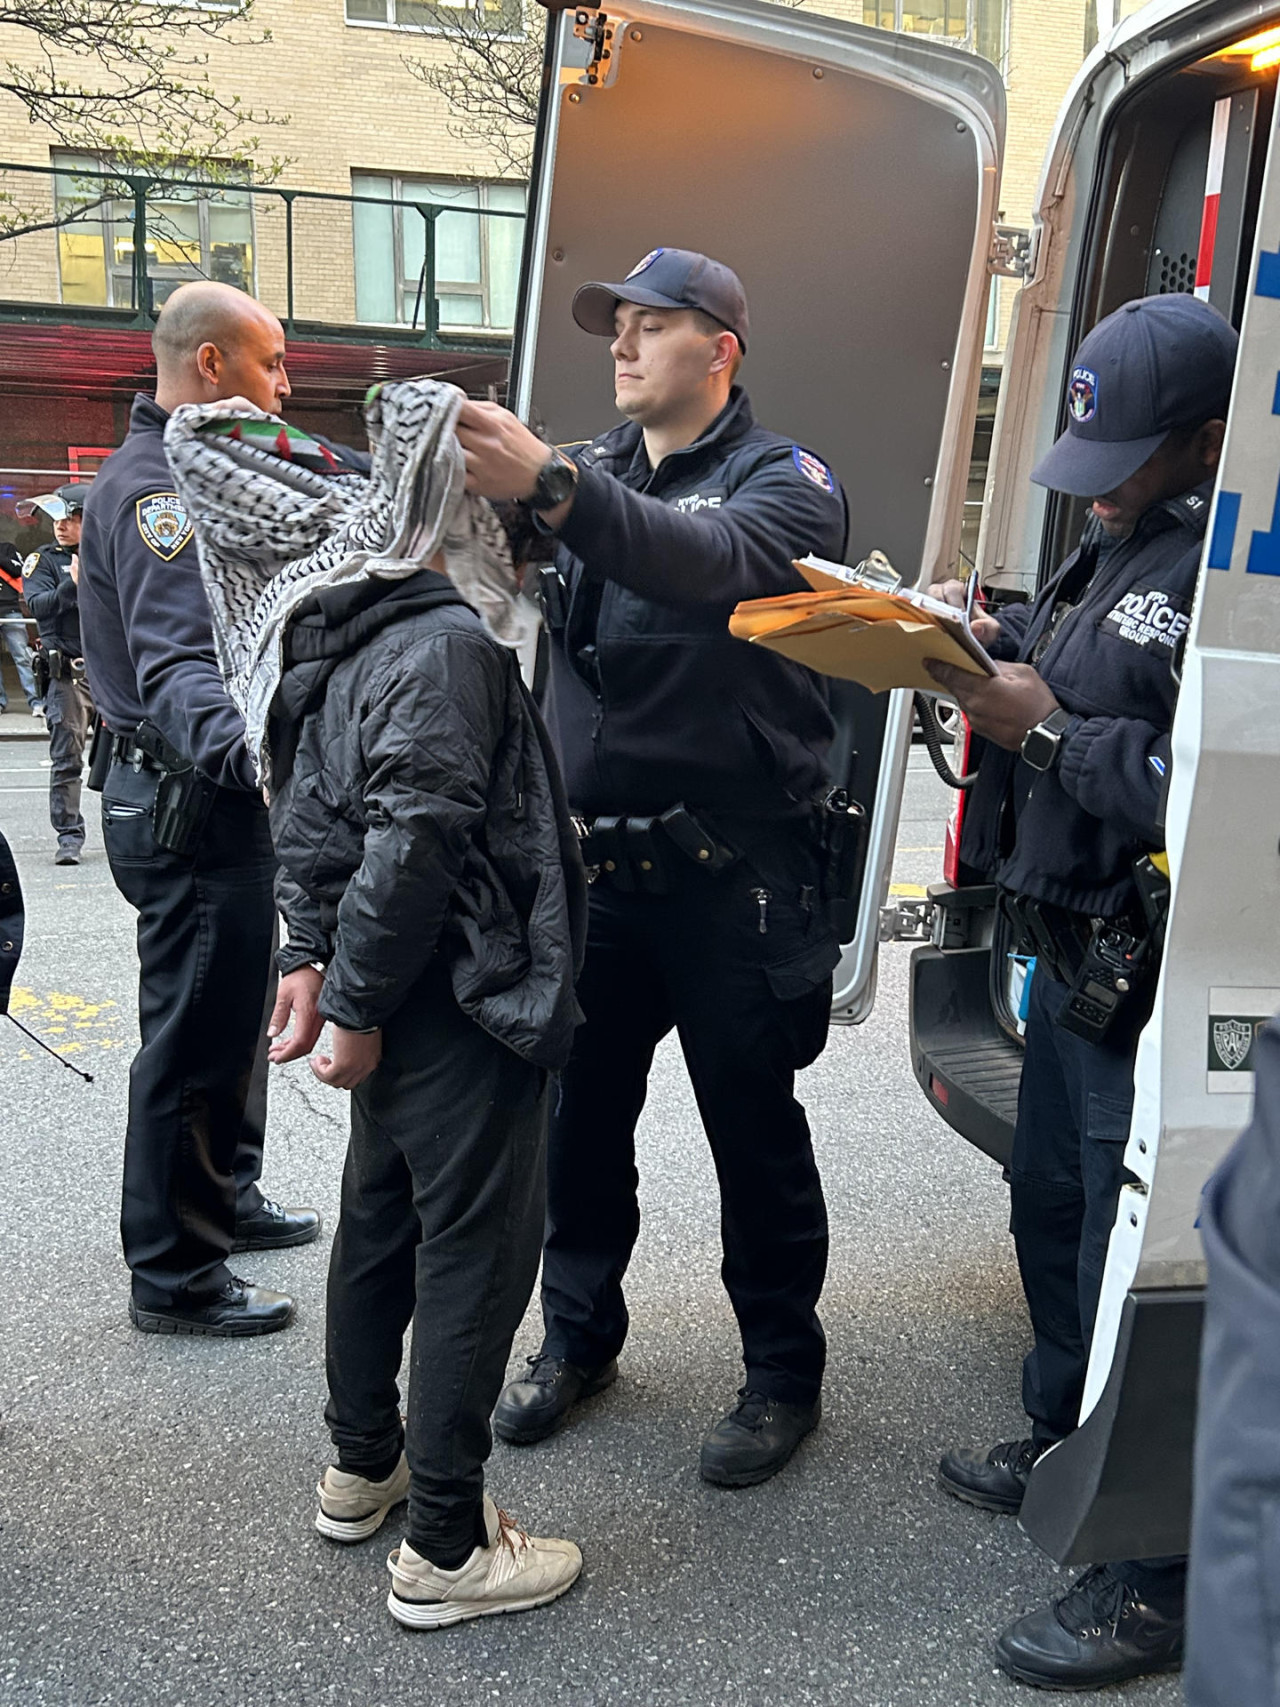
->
xmin=1010 ymin=970 xmax=1186 ymax=1610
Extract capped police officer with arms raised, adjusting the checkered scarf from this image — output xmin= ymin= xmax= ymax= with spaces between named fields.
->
xmin=457 ymin=249 xmax=847 ymax=1485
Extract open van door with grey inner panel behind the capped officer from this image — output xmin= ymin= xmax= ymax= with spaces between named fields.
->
xmin=510 ymin=0 xmax=1004 ymax=1021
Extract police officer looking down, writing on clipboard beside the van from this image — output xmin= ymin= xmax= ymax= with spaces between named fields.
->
xmin=934 ymin=295 xmax=1236 ymax=1688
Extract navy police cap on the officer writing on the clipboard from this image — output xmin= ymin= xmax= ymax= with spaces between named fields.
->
xmin=1031 ymin=294 xmax=1239 ymax=498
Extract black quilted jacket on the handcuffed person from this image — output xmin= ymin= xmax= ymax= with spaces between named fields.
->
xmin=271 ymin=570 xmax=585 ymax=1070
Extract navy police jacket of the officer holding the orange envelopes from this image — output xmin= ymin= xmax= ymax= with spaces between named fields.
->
xmin=961 ymin=485 xmax=1212 ymax=918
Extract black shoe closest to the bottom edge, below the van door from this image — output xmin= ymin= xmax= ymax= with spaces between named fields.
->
xmin=995 ymin=1565 xmax=1184 ymax=1690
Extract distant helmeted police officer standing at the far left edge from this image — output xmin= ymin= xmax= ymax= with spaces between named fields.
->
xmin=17 ymin=485 xmax=94 ymax=865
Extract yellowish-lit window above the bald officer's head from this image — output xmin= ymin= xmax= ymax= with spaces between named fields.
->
xmin=53 ymin=150 xmax=253 ymax=309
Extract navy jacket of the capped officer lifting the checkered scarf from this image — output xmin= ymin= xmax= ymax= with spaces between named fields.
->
xmin=544 ymin=387 xmax=847 ymax=819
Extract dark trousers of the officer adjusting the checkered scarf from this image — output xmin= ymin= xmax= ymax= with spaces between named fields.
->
xmin=543 ymin=838 xmax=838 ymax=1403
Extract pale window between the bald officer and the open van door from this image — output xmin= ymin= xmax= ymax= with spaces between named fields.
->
xmin=352 ymin=172 xmax=526 ymax=331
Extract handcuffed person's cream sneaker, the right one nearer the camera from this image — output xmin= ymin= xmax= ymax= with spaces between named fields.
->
xmin=387 ymin=1494 xmax=582 ymax=1630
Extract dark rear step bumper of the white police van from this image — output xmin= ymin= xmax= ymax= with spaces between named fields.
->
xmin=910 ymin=947 xmax=1022 ymax=1168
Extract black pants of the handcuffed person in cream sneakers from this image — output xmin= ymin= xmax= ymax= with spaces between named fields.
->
xmin=324 ymin=970 xmax=548 ymax=1562
